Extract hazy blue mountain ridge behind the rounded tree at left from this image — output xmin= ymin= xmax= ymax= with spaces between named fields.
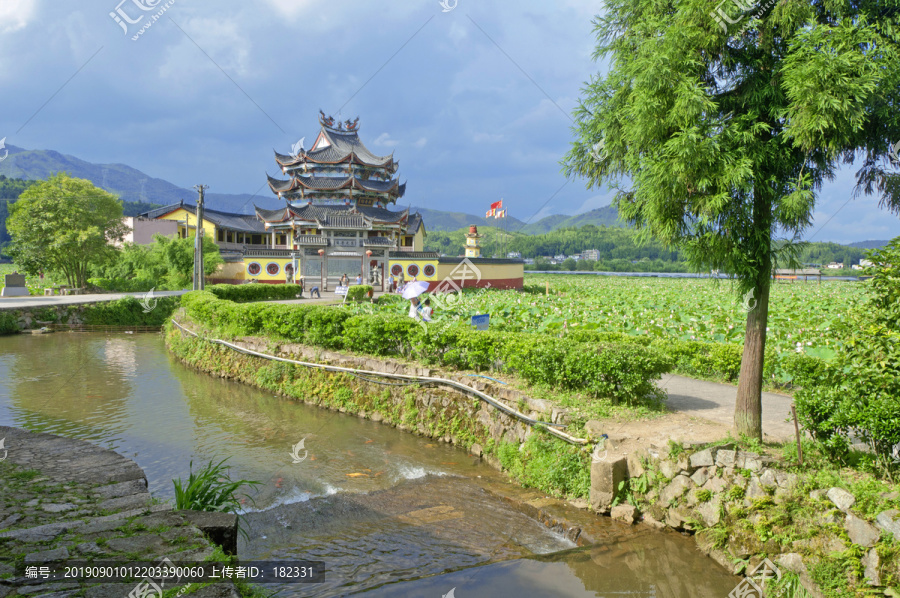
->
xmin=0 ymin=145 xmax=278 ymax=214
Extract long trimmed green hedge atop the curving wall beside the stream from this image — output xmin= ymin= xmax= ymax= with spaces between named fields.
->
xmin=182 ymin=291 xmax=673 ymax=401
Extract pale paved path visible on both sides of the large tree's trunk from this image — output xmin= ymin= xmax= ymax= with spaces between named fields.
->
xmin=658 ymin=374 xmax=794 ymax=440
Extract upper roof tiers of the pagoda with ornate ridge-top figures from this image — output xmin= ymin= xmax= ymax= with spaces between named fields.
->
xmin=269 ymin=110 xmax=406 ymax=207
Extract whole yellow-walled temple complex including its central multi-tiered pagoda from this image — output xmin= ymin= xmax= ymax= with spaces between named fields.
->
xmin=135 ymin=111 xmax=523 ymax=291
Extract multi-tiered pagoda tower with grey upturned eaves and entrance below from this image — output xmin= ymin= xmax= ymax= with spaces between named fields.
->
xmin=256 ymin=115 xmax=425 ymax=288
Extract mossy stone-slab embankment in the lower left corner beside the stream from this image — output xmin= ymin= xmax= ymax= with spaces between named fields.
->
xmin=0 ymin=426 xmax=237 ymax=598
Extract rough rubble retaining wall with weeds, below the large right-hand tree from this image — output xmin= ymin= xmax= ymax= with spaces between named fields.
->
xmin=590 ymin=440 xmax=900 ymax=596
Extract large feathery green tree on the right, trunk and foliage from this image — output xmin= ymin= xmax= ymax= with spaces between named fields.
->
xmin=563 ymin=0 xmax=900 ymax=438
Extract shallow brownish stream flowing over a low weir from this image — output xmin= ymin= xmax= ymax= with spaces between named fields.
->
xmin=0 ymin=333 xmax=737 ymax=598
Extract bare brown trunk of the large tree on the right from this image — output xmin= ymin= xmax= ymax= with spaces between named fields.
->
xmin=734 ymin=274 xmax=771 ymax=440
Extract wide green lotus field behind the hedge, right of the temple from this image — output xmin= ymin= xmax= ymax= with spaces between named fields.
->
xmin=376 ymin=274 xmax=862 ymax=366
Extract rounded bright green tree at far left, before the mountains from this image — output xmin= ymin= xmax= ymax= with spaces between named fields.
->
xmin=6 ymin=173 xmax=127 ymax=288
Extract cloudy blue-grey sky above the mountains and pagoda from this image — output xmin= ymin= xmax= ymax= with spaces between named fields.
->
xmin=0 ymin=0 xmax=900 ymax=243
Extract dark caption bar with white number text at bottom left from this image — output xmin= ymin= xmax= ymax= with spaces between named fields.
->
xmin=16 ymin=559 xmax=326 ymax=586
